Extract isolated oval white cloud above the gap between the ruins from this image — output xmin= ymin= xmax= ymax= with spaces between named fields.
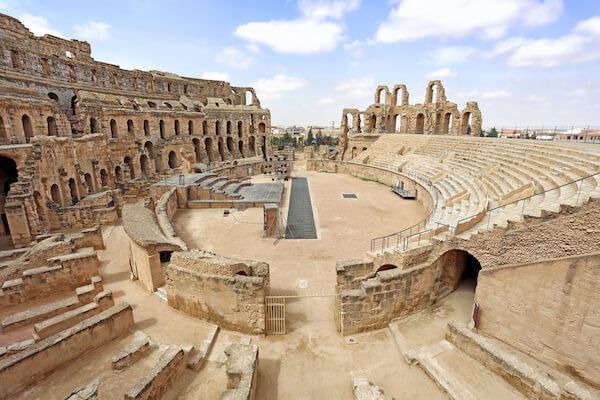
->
xmin=235 ymin=19 xmax=344 ymax=55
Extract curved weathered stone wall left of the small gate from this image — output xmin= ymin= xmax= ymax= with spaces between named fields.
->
xmin=166 ymin=250 xmax=269 ymax=335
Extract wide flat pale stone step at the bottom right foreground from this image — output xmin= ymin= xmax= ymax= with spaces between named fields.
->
xmin=414 ymin=340 xmax=526 ymax=400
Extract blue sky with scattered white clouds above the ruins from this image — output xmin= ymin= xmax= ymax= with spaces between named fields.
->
xmin=0 ymin=0 xmax=600 ymax=127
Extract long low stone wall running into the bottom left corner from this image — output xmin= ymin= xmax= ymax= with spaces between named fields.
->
xmin=0 ymin=303 xmax=133 ymax=399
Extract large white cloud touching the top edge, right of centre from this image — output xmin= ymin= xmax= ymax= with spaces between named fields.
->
xmin=375 ymin=0 xmax=562 ymax=43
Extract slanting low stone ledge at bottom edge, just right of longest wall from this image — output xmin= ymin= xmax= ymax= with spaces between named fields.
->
xmin=125 ymin=346 xmax=188 ymax=400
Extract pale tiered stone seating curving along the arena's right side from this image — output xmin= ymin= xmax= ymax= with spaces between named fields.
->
xmin=352 ymin=134 xmax=600 ymax=247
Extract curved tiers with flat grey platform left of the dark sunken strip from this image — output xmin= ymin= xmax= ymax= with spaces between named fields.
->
xmin=150 ymin=172 xmax=284 ymax=208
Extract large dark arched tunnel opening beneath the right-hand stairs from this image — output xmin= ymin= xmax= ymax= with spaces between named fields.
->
xmin=435 ymin=249 xmax=481 ymax=296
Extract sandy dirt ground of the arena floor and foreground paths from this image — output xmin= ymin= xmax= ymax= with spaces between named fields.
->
xmin=9 ymin=155 xmax=473 ymax=400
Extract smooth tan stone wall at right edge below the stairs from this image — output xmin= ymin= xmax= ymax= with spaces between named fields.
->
xmin=475 ymin=252 xmax=600 ymax=387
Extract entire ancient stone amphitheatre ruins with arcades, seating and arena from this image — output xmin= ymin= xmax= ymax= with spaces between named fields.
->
xmin=0 ymin=10 xmax=600 ymax=400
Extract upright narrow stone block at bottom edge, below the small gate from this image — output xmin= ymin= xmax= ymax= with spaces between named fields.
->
xmin=219 ymin=343 xmax=258 ymax=400
